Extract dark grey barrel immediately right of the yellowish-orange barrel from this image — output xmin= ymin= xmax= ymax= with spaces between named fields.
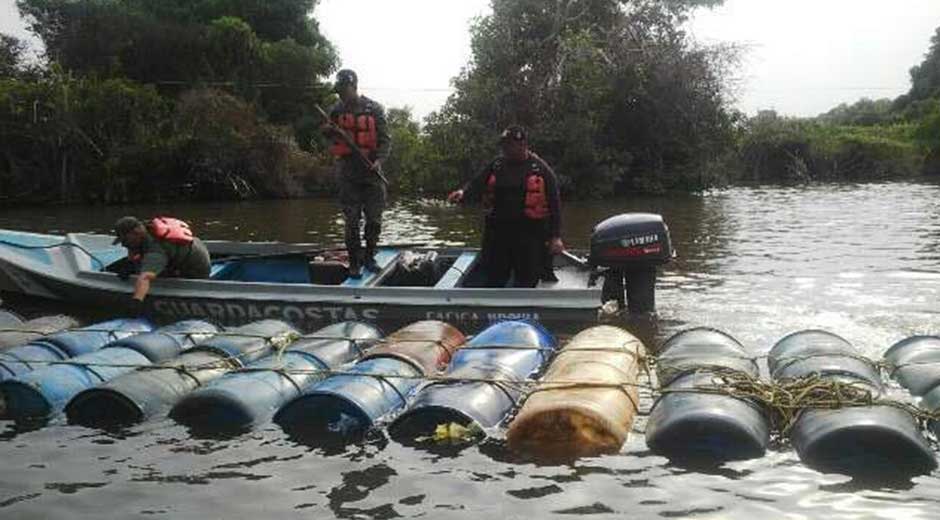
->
xmin=646 ymin=327 xmax=770 ymax=462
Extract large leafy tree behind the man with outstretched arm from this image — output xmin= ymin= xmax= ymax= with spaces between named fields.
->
xmin=426 ymin=0 xmax=735 ymax=196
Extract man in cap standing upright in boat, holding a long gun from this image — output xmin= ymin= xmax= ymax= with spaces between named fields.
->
xmin=324 ymin=69 xmax=392 ymax=278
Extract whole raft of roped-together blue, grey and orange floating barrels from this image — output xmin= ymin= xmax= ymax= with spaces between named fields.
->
xmin=0 ymin=311 xmax=940 ymax=474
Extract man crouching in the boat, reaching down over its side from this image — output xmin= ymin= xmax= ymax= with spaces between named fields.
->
xmin=114 ymin=217 xmax=210 ymax=308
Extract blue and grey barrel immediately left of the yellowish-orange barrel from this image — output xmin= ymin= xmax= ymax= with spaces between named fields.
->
xmin=389 ymin=321 xmax=556 ymax=444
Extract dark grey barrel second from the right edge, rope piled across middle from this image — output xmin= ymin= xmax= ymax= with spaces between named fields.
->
xmin=768 ymin=330 xmax=937 ymax=474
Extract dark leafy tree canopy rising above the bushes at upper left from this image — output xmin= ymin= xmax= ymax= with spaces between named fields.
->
xmin=17 ymin=0 xmax=337 ymax=124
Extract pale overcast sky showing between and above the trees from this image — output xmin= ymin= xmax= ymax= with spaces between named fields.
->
xmin=0 ymin=0 xmax=940 ymax=120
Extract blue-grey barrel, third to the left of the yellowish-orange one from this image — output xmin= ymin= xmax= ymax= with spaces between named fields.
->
xmin=170 ymin=321 xmax=382 ymax=432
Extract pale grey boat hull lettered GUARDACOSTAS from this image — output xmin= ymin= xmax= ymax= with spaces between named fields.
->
xmin=0 ymin=230 xmax=601 ymax=330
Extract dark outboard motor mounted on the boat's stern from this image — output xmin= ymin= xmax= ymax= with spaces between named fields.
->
xmin=588 ymin=213 xmax=674 ymax=312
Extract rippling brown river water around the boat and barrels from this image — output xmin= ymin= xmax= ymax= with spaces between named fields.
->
xmin=0 ymin=183 xmax=940 ymax=519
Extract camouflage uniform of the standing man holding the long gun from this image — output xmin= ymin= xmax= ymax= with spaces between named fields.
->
xmin=330 ymin=96 xmax=392 ymax=264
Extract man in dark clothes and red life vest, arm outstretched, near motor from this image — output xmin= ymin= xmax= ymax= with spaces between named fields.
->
xmin=447 ymin=126 xmax=565 ymax=287
